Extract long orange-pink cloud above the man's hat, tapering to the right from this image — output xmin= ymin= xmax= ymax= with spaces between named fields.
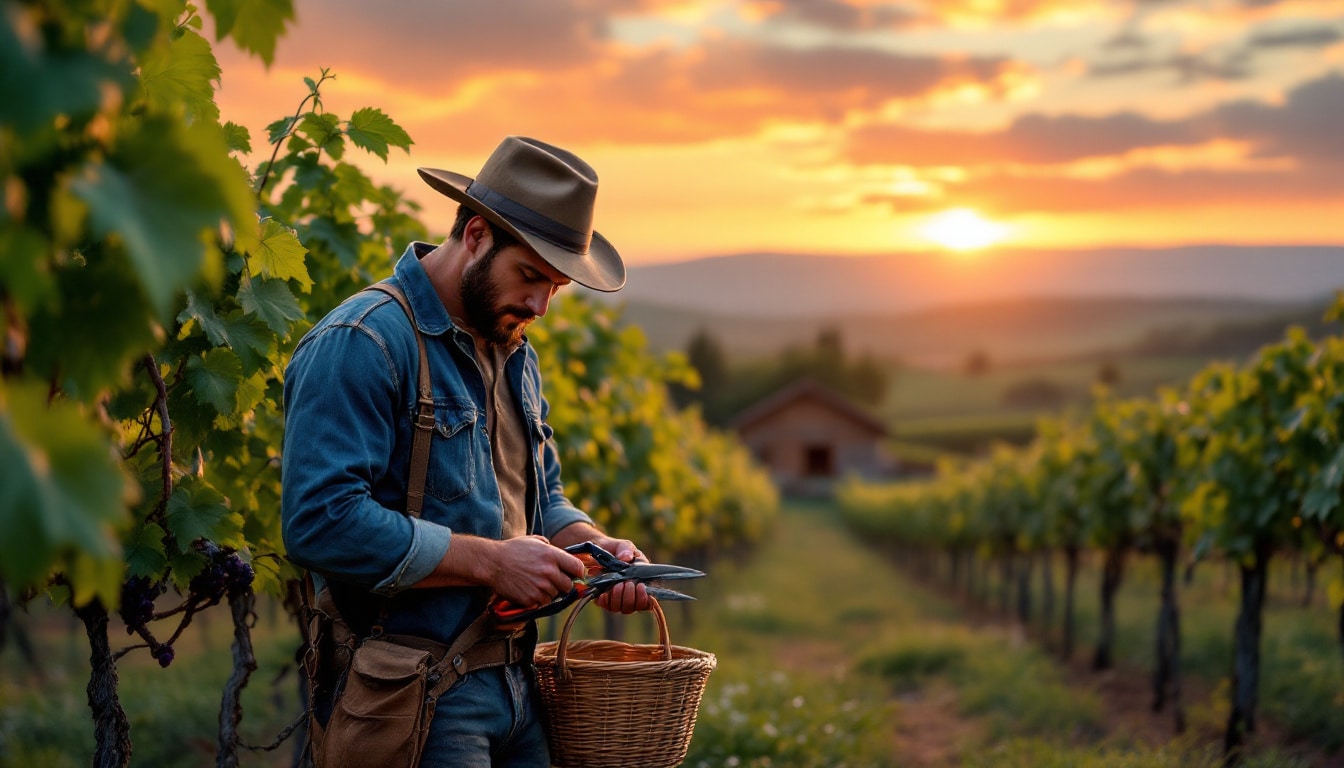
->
xmin=223 ymin=12 xmax=1021 ymax=156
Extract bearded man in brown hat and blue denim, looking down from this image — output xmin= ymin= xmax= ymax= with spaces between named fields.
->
xmin=282 ymin=137 xmax=650 ymax=768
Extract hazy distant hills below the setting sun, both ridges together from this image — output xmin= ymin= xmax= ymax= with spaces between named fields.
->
xmin=585 ymin=246 xmax=1344 ymax=367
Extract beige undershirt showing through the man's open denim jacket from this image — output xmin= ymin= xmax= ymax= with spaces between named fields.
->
xmin=473 ymin=336 xmax=531 ymax=538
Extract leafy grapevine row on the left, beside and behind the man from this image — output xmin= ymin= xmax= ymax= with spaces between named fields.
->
xmin=0 ymin=0 xmax=775 ymax=765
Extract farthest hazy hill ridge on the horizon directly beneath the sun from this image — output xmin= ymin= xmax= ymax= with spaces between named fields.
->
xmin=599 ymin=245 xmax=1344 ymax=317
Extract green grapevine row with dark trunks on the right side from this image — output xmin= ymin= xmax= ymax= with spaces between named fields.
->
xmin=841 ymin=295 xmax=1344 ymax=755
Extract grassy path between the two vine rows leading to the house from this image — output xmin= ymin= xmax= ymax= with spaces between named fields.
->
xmin=669 ymin=504 xmax=1333 ymax=768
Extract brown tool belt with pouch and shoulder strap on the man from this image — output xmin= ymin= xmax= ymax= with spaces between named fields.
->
xmin=304 ymin=282 xmax=531 ymax=768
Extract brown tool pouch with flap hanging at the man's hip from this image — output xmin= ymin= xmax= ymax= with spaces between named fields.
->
xmin=313 ymin=638 xmax=434 ymax=768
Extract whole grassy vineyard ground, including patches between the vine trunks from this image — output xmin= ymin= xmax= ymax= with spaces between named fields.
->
xmin=0 ymin=503 xmax=1344 ymax=768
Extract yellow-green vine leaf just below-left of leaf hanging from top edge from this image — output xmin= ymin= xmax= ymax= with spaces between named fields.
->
xmin=140 ymin=30 xmax=219 ymax=122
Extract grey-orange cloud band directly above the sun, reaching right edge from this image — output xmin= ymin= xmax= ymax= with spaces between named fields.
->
xmin=848 ymin=74 xmax=1344 ymax=213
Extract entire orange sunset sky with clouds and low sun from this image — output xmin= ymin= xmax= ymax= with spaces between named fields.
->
xmin=216 ymin=0 xmax=1344 ymax=264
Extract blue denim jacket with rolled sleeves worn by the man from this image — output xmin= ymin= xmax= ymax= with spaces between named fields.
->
xmin=281 ymin=242 xmax=591 ymax=643
